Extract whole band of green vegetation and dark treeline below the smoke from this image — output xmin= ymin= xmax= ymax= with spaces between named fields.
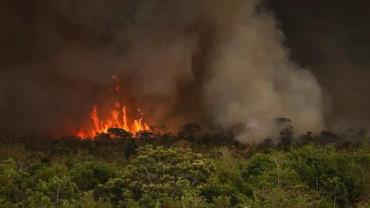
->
xmin=0 ymin=125 xmax=370 ymax=208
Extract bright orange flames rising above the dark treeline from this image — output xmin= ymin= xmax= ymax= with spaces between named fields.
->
xmin=76 ymin=103 xmax=150 ymax=139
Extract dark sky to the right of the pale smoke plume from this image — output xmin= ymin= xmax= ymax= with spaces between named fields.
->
xmin=267 ymin=0 xmax=370 ymax=127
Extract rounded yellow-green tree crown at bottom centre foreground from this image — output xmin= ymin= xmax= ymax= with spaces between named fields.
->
xmin=124 ymin=146 xmax=213 ymax=207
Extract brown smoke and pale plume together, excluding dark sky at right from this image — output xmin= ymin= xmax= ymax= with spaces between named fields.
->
xmin=0 ymin=0 xmax=323 ymax=142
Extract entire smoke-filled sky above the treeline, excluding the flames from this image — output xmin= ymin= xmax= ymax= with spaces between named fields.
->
xmin=0 ymin=0 xmax=370 ymax=141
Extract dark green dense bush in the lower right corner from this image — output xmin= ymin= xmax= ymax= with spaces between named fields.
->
xmin=291 ymin=146 xmax=370 ymax=206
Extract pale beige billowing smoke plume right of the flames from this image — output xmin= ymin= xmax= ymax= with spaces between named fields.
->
xmin=205 ymin=1 xmax=323 ymax=142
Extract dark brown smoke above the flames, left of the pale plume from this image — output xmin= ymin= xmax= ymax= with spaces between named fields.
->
xmin=0 ymin=0 xmax=229 ymax=135
